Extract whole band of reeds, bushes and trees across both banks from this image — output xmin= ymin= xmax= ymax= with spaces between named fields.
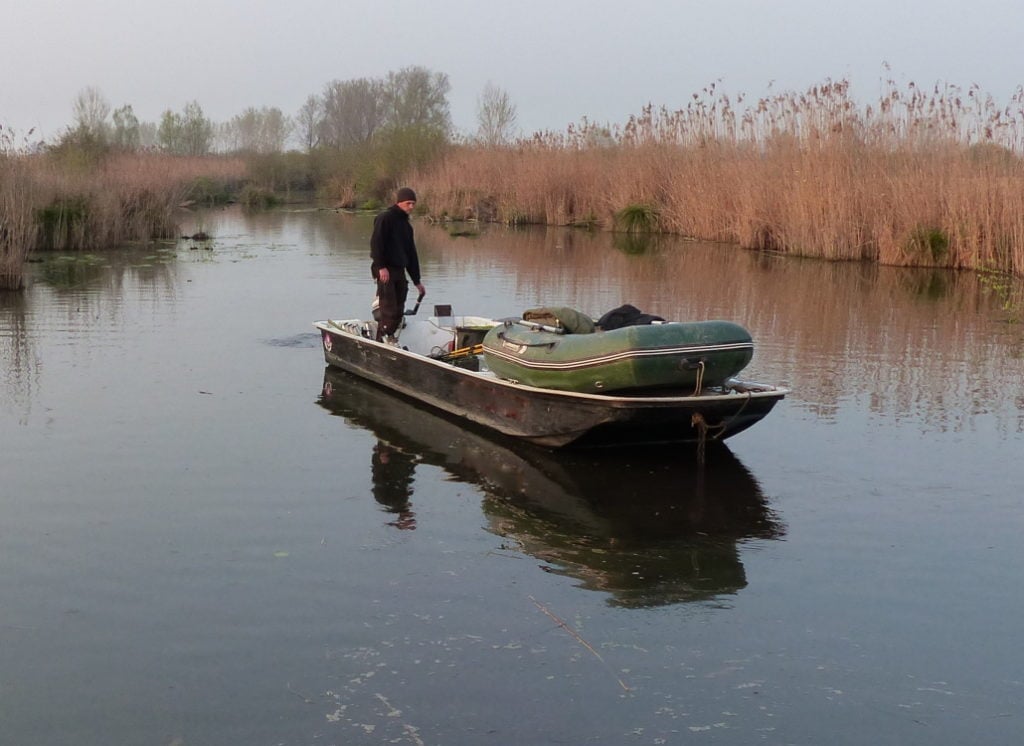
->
xmin=0 ymin=67 xmax=1024 ymax=287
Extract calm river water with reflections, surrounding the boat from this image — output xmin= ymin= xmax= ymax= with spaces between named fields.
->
xmin=0 ymin=204 xmax=1024 ymax=746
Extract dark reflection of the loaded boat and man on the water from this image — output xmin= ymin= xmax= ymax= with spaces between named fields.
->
xmin=319 ymin=367 xmax=783 ymax=607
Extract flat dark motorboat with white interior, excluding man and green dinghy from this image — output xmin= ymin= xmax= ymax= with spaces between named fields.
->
xmin=313 ymin=308 xmax=788 ymax=448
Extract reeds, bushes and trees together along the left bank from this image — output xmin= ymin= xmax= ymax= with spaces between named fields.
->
xmin=0 ymin=67 xmax=452 ymax=289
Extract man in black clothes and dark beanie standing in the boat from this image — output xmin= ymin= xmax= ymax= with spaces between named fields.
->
xmin=370 ymin=186 xmax=427 ymax=342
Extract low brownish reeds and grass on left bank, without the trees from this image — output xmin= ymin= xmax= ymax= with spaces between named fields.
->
xmin=0 ymin=153 xmax=245 ymax=289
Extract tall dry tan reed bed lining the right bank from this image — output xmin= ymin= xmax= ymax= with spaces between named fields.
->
xmin=411 ymin=82 xmax=1024 ymax=274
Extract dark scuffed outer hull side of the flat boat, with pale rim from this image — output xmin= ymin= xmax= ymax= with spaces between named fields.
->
xmin=314 ymin=321 xmax=788 ymax=447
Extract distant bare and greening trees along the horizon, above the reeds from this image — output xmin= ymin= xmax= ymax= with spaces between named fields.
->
xmin=16 ymin=67 xmax=462 ymax=199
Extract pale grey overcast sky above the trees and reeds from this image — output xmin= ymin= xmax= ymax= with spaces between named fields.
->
xmin=0 ymin=0 xmax=1024 ymax=144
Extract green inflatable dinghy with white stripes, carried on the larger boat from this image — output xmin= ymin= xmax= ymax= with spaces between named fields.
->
xmin=483 ymin=321 xmax=754 ymax=394
